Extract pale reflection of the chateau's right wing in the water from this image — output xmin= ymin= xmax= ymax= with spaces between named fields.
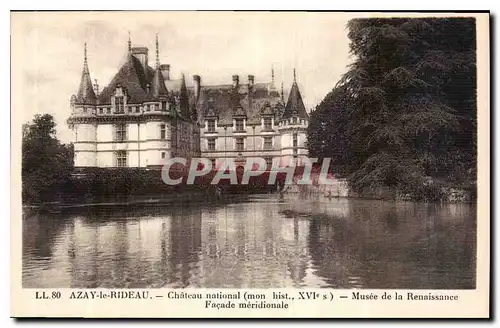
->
xmin=196 ymin=197 xmax=308 ymax=288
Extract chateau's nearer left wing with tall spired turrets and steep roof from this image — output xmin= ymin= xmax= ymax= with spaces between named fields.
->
xmin=68 ymin=37 xmax=200 ymax=167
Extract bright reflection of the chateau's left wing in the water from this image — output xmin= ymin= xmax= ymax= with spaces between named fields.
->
xmin=60 ymin=208 xmax=201 ymax=288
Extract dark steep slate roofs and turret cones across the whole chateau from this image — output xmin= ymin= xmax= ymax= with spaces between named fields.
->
xmin=77 ymin=47 xmax=309 ymax=125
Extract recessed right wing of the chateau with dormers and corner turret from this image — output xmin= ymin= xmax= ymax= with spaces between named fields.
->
xmin=198 ymin=69 xmax=309 ymax=167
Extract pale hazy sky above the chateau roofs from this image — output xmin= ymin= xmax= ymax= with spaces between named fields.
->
xmin=11 ymin=12 xmax=353 ymax=143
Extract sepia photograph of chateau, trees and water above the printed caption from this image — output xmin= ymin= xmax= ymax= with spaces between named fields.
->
xmin=11 ymin=11 xmax=489 ymax=318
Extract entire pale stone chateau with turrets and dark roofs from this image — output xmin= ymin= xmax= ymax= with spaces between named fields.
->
xmin=68 ymin=37 xmax=309 ymax=168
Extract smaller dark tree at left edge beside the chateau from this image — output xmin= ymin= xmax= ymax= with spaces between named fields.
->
xmin=22 ymin=114 xmax=73 ymax=203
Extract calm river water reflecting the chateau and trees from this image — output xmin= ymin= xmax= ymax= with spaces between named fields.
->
xmin=23 ymin=194 xmax=476 ymax=289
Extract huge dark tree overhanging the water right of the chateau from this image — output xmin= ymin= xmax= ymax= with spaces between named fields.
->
xmin=309 ymin=18 xmax=477 ymax=200
